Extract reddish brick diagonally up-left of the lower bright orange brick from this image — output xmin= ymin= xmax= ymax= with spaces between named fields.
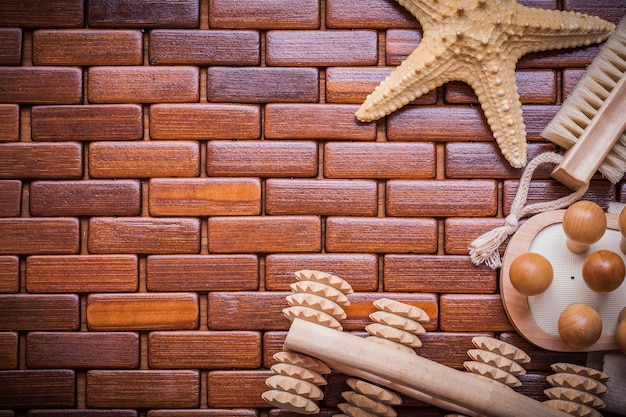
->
xmin=26 ymin=255 xmax=139 ymax=293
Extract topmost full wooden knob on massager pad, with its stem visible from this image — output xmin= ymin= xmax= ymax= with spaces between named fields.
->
xmin=563 ymin=200 xmax=607 ymax=253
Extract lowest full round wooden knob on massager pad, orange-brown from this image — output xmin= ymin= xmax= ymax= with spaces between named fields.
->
xmin=558 ymin=303 xmax=602 ymax=349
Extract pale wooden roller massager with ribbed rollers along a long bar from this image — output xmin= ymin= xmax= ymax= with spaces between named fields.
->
xmin=262 ymin=270 xmax=592 ymax=417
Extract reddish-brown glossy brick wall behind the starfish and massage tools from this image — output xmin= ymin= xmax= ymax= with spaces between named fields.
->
xmin=0 ymin=0 xmax=626 ymax=417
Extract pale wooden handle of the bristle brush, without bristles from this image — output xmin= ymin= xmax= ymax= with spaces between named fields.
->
xmin=552 ymin=77 xmax=626 ymax=190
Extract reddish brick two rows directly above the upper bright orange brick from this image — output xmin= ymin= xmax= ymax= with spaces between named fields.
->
xmin=150 ymin=104 xmax=261 ymax=140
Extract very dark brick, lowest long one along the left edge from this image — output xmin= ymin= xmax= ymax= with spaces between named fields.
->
xmin=0 ymin=369 xmax=76 ymax=408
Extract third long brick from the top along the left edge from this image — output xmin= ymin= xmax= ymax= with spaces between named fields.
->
xmin=0 ymin=142 xmax=83 ymax=179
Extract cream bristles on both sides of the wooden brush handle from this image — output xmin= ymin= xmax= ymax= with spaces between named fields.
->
xmin=542 ymin=18 xmax=626 ymax=184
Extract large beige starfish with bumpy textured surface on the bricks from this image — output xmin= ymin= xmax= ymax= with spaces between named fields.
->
xmin=356 ymin=0 xmax=615 ymax=168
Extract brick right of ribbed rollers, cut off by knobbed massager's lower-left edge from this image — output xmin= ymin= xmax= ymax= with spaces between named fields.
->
xmin=439 ymin=294 xmax=514 ymax=332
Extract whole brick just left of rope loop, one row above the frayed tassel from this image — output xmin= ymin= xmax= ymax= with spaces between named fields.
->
xmin=385 ymin=180 xmax=498 ymax=217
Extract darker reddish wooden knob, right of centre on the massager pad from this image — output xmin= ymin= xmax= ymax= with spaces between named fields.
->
xmin=583 ymin=250 xmax=626 ymax=292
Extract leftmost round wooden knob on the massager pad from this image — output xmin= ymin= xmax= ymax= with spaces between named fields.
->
xmin=509 ymin=252 xmax=554 ymax=297
